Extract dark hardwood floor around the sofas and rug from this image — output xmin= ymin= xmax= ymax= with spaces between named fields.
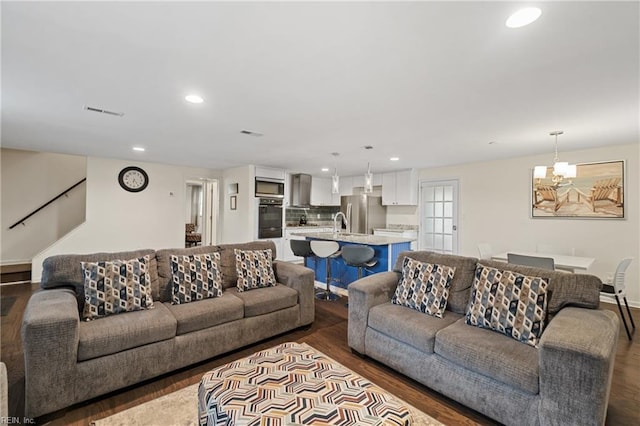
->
xmin=0 ymin=284 xmax=640 ymax=426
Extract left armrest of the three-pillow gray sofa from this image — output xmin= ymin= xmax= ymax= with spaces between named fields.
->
xmin=22 ymin=289 xmax=80 ymax=417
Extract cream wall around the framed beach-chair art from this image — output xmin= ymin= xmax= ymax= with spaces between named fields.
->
xmin=416 ymin=143 xmax=640 ymax=306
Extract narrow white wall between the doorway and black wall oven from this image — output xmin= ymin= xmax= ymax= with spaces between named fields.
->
xmin=220 ymin=166 xmax=258 ymax=244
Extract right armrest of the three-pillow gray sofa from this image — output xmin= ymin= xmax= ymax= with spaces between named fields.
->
xmin=273 ymin=261 xmax=316 ymax=326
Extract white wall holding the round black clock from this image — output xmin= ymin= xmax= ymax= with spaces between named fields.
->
xmin=32 ymin=157 xmax=220 ymax=281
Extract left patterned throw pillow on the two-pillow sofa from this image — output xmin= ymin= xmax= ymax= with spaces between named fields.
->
xmin=391 ymin=257 xmax=456 ymax=318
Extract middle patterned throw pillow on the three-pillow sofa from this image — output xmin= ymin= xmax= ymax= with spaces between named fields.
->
xmin=171 ymin=253 xmax=222 ymax=305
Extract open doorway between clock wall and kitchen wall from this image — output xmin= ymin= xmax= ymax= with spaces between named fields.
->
xmin=185 ymin=179 xmax=218 ymax=247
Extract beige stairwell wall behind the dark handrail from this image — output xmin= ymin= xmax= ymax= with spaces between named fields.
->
xmin=0 ymin=148 xmax=87 ymax=264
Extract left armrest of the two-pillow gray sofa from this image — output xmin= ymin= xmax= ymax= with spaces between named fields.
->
xmin=349 ymin=271 xmax=400 ymax=355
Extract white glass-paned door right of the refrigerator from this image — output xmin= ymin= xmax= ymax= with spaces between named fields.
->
xmin=420 ymin=180 xmax=458 ymax=254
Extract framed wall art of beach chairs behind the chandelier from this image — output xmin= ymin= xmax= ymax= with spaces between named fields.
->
xmin=531 ymin=160 xmax=625 ymax=219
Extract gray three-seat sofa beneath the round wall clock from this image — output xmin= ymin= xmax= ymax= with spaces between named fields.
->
xmin=22 ymin=241 xmax=315 ymax=417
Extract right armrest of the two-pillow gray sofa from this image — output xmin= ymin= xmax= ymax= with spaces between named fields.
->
xmin=539 ymin=307 xmax=620 ymax=425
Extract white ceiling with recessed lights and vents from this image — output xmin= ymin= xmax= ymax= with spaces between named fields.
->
xmin=1 ymin=1 xmax=640 ymax=175
